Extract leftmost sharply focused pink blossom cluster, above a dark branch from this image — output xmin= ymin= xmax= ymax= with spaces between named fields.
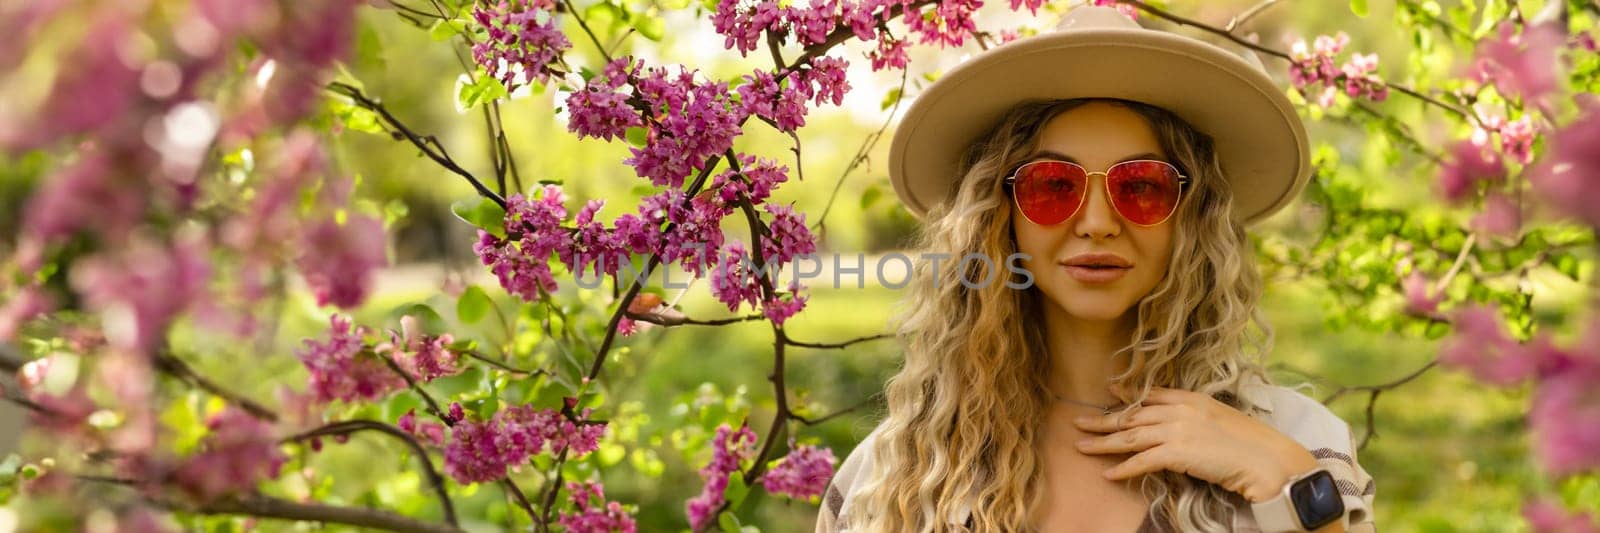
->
xmin=296 ymin=314 xmax=406 ymax=402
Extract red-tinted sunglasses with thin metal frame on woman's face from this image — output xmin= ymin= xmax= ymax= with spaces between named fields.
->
xmin=1005 ymin=158 xmax=1189 ymax=226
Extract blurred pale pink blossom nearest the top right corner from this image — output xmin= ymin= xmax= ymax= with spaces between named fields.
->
xmin=1472 ymin=21 xmax=1566 ymax=102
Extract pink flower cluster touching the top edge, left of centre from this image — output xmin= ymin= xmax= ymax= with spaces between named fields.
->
xmin=472 ymin=0 xmax=573 ymax=90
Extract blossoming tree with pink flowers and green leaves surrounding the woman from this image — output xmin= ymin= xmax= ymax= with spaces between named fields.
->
xmin=0 ymin=0 xmax=1600 ymax=531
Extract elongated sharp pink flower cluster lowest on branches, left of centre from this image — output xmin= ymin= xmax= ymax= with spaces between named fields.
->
xmin=445 ymin=405 xmax=606 ymax=483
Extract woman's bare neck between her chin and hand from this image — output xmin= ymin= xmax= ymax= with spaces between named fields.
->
xmin=1043 ymin=296 xmax=1138 ymax=405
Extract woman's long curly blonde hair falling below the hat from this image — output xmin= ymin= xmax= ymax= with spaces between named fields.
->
xmin=851 ymin=98 xmax=1272 ymax=531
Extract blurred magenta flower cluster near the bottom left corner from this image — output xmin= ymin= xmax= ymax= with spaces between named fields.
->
xmin=173 ymin=407 xmax=288 ymax=501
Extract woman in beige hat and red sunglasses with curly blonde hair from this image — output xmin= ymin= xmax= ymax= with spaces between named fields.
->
xmin=816 ymin=6 xmax=1374 ymax=531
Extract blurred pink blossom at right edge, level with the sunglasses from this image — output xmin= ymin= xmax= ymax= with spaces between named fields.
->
xmin=1528 ymin=94 xmax=1600 ymax=227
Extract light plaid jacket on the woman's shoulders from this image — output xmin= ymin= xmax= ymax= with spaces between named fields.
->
xmin=816 ymin=379 xmax=1378 ymax=533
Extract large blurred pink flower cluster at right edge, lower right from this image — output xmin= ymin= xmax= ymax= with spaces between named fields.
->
xmin=1438 ymin=306 xmax=1600 ymax=475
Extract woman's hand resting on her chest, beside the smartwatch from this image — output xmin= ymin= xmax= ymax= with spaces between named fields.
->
xmin=1074 ymin=386 xmax=1317 ymax=503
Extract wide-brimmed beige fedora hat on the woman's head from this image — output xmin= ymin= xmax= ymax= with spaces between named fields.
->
xmin=890 ymin=5 xmax=1310 ymax=224
